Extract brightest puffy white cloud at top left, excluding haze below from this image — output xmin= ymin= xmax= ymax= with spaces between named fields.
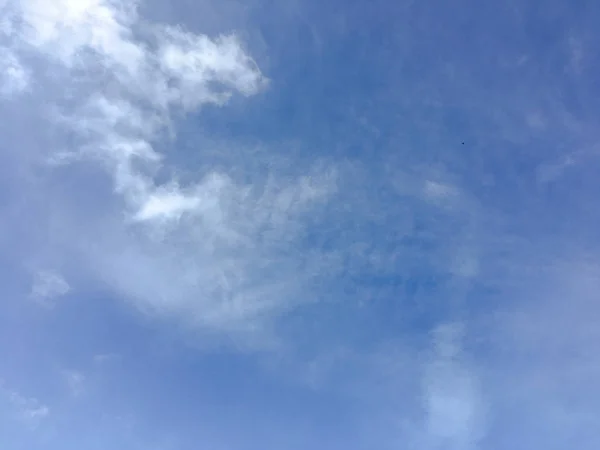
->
xmin=4 ymin=0 xmax=265 ymax=229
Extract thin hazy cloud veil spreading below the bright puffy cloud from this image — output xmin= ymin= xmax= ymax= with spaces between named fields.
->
xmin=82 ymin=167 xmax=333 ymax=343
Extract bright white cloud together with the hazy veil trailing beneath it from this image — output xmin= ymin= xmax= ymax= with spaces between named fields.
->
xmin=1 ymin=0 xmax=336 ymax=344
